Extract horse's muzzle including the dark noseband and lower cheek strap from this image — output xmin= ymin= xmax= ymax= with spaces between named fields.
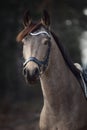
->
xmin=23 ymin=56 xmax=48 ymax=84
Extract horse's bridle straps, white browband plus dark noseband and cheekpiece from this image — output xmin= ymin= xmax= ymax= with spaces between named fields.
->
xmin=23 ymin=31 xmax=51 ymax=71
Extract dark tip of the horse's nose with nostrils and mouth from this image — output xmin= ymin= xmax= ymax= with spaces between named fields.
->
xmin=23 ymin=67 xmax=39 ymax=84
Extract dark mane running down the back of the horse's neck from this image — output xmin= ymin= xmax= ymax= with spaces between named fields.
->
xmin=51 ymin=31 xmax=81 ymax=80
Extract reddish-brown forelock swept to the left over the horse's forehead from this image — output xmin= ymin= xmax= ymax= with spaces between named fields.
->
xmin=16 ymin=22 xmax=44 ymax=42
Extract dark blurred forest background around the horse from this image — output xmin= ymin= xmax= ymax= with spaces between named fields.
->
xmin=0 ymin=0 xmax=87 ymax=130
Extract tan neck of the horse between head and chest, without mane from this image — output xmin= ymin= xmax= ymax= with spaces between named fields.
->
xmin=40 ymin=35 xmax=79 ymax=110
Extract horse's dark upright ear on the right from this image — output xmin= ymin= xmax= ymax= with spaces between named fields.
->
xmin=41 ymin=10 xmax=50 ymax=27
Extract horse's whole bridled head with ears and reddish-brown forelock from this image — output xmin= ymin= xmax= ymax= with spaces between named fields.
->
xmin=17 ymin=11 xmax=51 ymax=83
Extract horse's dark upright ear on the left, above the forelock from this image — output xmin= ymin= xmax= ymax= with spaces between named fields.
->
xmin=23 ymin=10 xmax=32 ymax=27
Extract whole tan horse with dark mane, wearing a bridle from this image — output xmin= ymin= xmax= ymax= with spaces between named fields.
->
xmin=17 ymin=11 xmax=87 ymax=130
